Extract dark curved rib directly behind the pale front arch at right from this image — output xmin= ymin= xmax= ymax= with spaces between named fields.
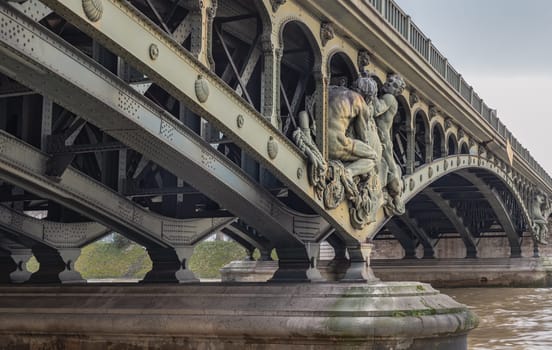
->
xmin=458 ymin=171 xmax=521 ymax=258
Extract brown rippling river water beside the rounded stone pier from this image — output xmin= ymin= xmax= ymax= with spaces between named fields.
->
xmin=441 ymin=288 xmax=552 ymax=350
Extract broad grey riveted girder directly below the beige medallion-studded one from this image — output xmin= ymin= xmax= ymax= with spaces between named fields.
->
xmin=0 ymin=5 xmax=330 ymax=246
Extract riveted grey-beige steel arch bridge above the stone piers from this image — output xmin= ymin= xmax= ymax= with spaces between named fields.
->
xmin=0 ymin=0 xmax=552 ymax=283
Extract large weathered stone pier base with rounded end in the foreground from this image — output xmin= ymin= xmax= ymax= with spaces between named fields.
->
xmin=0 ymin=282 xmax=477 ymax=350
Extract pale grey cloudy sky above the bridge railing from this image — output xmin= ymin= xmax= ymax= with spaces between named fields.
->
xmin=395 ymin=0 xmax=552 ymax=175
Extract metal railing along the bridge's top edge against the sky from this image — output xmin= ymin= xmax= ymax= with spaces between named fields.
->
xmin=364 ymin=0 xmax=552 ymax=187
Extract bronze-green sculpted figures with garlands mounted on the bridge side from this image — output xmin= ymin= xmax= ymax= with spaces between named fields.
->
xmin=293 ymin=74 xmax=405 ymax=229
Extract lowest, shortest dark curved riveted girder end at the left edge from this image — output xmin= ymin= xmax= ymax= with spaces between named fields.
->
xmin=0 ymin=205 xmax=112 ymax=248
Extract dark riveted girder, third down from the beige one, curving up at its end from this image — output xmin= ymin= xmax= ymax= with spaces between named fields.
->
xmin=0 ymin=131 xmax=233 ymax=247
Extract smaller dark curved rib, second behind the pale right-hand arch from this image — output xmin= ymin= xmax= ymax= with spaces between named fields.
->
xmin=423 ymin=187 xmax=477 ymax=258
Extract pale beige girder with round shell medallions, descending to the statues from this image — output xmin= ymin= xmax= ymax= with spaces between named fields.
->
xmin=35 ymin=0 xmax=362 ymax=243
